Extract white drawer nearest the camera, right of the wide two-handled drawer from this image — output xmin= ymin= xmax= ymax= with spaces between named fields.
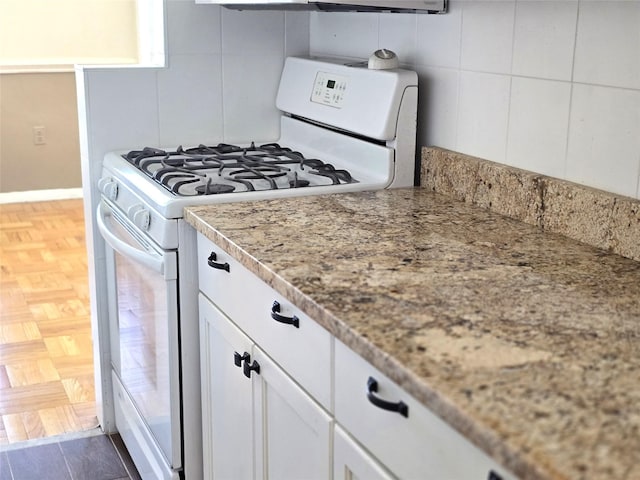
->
xmin=335 ymin=340 xmax=515 ymax=480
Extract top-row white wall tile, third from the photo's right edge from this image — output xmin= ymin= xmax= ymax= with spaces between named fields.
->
xmin=460 ymin=0 xmax=515 ymax=73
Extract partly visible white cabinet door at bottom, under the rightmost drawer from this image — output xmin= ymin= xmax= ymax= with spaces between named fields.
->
xmin=333 ymin=425 xmax=394 ymax=480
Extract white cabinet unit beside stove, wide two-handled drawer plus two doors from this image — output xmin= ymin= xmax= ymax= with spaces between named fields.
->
xmin=198 ymin=232 xmax=332 ymax=480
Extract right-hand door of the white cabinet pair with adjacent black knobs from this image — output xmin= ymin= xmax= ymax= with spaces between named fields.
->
xmin=254 ymin=347 xmax=332 ymax=480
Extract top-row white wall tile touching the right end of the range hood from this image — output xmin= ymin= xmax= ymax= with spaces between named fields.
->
xmin=416 ymin=2 xmax=462 ymax=68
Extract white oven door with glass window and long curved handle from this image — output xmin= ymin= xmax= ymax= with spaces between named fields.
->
xmin=97 ymin=199 xmax=182 ymax=478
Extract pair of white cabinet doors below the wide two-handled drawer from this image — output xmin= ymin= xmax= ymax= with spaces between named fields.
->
xmin=199 ymin=295 xmax=332 ymax=480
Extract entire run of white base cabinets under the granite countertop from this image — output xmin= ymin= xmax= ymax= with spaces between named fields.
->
xmin=198 ymin=235 xmax=515 ymax=480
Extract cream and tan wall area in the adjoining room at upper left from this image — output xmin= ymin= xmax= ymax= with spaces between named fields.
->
xmin=0 ymin=0 xmax=138 ymax=193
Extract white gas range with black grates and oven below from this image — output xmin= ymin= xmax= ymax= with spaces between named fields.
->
xmin=97 ymin=52 xmax=418 ymax=480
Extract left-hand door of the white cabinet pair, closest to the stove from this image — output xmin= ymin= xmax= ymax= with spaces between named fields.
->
xmin=199 ymin=295 xmax=255 ymax=480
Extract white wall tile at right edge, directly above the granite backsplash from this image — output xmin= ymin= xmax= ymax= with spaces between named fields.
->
xmin=567 ymin=84 xmax=640 ymax=196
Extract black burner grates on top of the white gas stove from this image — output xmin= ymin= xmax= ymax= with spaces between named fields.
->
xmin=123 ymin=143 xmax=357 ymax=196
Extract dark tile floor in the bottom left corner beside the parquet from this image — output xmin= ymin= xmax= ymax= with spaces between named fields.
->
xmin=0 ymin=434 xmax=140 ymax=480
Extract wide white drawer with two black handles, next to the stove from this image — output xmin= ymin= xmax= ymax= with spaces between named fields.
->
xmin=198 ymin=234 xmax=332 ymax=410
